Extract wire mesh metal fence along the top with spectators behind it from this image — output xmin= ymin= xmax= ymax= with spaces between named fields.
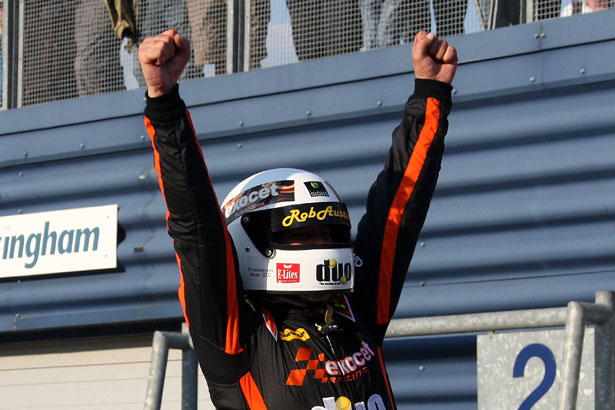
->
xmin=0 ymin=0 xmax=613 ymax=109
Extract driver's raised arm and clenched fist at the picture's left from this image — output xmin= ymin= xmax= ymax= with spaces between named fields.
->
xmin=139 ymin=30 xmax=253 ymax=383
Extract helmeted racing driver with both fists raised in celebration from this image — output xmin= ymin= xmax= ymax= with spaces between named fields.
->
xmin=139 ymin=30 xmax=457 ymax=410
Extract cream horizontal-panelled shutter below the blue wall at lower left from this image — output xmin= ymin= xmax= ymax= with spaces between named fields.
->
xmin=0 ymin=334 xmax=214 ymax=410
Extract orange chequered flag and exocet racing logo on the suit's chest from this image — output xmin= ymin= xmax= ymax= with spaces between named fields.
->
xmin=286 ymin=341 xmax=375 ymax=386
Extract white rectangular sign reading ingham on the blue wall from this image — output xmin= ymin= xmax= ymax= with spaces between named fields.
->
xmin=0 ymin=205 xmax=117 ymax=278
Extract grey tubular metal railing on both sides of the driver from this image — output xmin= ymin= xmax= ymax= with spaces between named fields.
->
xmin=145 ymin=291 xmax=615 ymax=410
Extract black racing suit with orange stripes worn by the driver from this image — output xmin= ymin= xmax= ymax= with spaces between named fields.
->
xmin=145 ymin=80 xmax=451 ymax=410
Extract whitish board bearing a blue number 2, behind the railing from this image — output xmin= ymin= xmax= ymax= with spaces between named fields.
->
xmin=477 ymin=328 xmax=596 ymax=410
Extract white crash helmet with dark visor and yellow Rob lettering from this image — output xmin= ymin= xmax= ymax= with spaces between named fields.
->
xmin=222 ymin=168 xmax=354 ymax=294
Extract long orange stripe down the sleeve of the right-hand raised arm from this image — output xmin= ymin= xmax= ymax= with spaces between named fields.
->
xmin=377 ymin=98 xmax=440 ymax=324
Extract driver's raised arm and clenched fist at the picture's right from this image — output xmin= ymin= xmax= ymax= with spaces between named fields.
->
xmin=352 ymin=32 xmax=457 ymax=338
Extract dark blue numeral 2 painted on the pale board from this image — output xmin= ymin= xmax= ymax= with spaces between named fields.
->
xmin=513 ymin=343 xmax=556 ymax=410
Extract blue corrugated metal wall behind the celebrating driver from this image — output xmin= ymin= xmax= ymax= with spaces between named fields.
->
xmin=0 ymin=10 xmax=615 ymax=410
